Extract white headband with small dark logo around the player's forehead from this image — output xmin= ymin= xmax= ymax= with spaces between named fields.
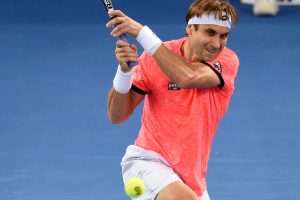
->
xmin=188 ymin=13 xmax=231 ymax=28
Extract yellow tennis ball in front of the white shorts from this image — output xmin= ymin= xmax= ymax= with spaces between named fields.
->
xmin=125 ymin=178 xmax=145 ymax=197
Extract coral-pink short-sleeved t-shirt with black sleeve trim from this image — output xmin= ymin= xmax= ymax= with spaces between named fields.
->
xmin=133 ymin=38 xmax=239 ymax=196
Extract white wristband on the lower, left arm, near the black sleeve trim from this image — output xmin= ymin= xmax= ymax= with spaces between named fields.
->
xmin=113 ymin=65 xmax=133 ymax=94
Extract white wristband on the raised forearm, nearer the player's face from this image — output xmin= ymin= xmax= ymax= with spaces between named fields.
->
xmin=136 ymin=26 xmax=162 ymax=55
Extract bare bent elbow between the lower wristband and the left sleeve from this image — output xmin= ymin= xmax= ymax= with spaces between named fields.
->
xmin=108 ymin=87 xmax=144 ymax=124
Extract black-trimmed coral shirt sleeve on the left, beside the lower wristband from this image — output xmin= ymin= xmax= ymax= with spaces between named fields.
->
xmin=131 ymin=51 xmax=151 ymax=95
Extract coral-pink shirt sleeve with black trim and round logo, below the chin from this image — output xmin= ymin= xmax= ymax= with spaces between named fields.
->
xmin=205 ymin=48 xmax=239 ymax=95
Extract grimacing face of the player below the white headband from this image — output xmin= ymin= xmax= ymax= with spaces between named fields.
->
xmin=186 ymin=25 xmax=229 ymax=62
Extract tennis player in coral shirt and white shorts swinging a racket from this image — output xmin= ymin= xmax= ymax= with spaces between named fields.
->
xmin=106 ymin=0 xmax=239 ymax=200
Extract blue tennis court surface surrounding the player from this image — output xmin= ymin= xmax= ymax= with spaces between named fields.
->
xmin=0 ymin=0 xmax=300 ymax=200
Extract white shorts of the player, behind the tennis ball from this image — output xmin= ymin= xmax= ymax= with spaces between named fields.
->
xmin=121 ymin=145 xmax=210 ymax=200
